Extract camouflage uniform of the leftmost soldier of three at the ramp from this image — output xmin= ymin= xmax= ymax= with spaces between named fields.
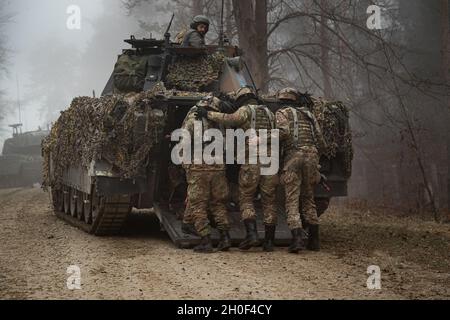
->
xmin=183 ymin=107 xmax=230 ymax=237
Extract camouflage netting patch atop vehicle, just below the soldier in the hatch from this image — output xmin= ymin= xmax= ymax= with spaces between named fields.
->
xmin=165 ymin=53 xmax=225 ymax=92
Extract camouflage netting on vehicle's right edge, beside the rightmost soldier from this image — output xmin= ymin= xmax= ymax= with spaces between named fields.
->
xmin=313 ymin=98 xmax=353 ymax=178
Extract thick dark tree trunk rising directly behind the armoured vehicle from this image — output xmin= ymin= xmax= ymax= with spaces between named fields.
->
xmin=233 ymin=0 xmax=269 ymax=92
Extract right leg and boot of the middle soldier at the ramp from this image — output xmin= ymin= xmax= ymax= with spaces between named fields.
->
xmin=259 ymin=175 xmax=279 ymax=252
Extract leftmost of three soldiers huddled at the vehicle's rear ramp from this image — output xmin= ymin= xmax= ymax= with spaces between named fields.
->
xmin=182 ymin=97 xmax=231 ymax=253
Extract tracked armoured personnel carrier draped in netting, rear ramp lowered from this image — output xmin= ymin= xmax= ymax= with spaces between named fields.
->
xmin=43 ymin=34 xmax=348 ymax=247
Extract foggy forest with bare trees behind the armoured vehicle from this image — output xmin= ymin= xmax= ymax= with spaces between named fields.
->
xmin=0 ymin=0 xmax=450 ymax=220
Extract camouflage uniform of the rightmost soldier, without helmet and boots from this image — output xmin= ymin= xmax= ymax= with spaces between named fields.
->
xmin=276 ymin=106 xmax=326 ymax=230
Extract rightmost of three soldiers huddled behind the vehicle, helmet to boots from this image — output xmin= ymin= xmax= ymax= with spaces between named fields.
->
xmin=276 ymin=88 xmax=326 ymax=253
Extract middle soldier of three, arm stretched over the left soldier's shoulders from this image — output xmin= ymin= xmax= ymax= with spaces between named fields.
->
xmin=200 ymin=87 xmax=279 ymax=251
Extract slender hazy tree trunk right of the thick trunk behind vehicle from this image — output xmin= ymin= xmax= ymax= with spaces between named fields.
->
xmin=320 ymin=0 xmax=333 ymax=99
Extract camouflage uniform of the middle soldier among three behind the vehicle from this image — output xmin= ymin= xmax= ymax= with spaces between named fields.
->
xmin=208 ymin=105 xmax=279 ymax=225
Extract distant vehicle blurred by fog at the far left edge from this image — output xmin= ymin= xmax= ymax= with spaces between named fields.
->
xmin=0 ymin=124 xmax=49 ymax=188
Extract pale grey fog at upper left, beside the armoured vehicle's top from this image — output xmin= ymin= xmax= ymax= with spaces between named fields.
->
xmin=0 ymin=0 xmax=138 ymax=142
